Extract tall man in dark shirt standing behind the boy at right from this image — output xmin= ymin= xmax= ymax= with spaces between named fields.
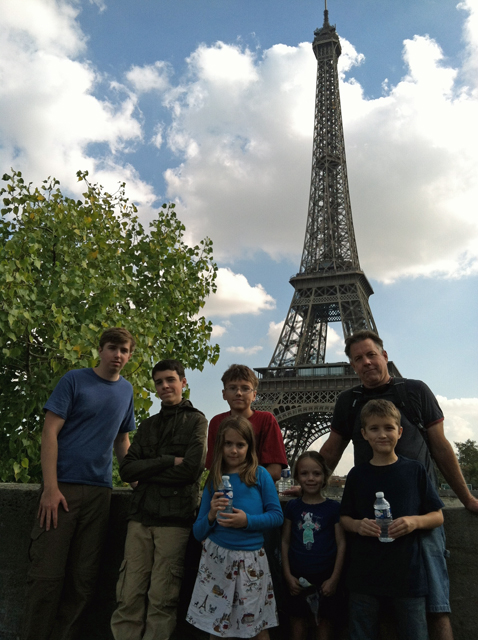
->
xmin=320 ymin=331 xmax=478 ymax=640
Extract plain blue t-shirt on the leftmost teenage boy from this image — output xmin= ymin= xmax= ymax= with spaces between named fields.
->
xmin=44 ymin=369 xmax=135 ymax=487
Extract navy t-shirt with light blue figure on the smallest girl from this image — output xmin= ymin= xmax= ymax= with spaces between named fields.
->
xmin=284 ymin=498 xmax=340 ymax=578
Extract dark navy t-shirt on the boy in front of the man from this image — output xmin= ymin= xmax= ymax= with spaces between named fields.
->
xmin=340 ymin=456 xmax=443 ymax=597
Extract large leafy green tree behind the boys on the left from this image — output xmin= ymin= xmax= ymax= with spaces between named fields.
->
xmin=0 ymin=171 xmax=219 ymax=482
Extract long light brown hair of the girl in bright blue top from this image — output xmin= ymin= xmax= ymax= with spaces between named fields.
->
xmin=207 ymin=416 xmax=259 ymax=493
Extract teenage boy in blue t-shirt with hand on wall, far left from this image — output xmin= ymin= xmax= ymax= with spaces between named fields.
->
xmin=23 ymin=328 xmax=135 ymax=640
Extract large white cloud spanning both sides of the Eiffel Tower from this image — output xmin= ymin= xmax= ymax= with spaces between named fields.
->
xmin=159 ymin=0 xmax=478 ymax=281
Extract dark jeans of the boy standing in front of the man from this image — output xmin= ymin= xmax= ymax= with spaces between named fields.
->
xmin=349 ymin=593 xmax=428 ymax=640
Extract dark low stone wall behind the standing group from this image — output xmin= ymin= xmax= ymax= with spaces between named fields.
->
xmin=0 ymin=484 xmax=478 ymax=640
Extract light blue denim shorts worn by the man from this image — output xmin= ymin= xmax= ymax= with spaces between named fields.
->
xmin=420 ymin=525 xmax=451 ymax=613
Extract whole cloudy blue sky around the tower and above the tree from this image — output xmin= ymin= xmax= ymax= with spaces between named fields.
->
xmin=0 ymin=0 xmax=478 ymax=471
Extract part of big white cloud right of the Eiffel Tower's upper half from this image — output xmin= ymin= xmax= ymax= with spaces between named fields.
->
xmin=343 ymin=27 xmax=478 ymax=281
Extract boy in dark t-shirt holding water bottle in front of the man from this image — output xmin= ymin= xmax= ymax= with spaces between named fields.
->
xmin=340 ymin=400 xmax=443 ymax=640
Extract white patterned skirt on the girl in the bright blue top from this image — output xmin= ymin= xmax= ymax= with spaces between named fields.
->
xmin=186 ymin=538 xmax=279 ymax=638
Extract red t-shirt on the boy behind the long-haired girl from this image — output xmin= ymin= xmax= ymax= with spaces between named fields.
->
xmin=206 ymin=411 xmax=287 ymax=469
